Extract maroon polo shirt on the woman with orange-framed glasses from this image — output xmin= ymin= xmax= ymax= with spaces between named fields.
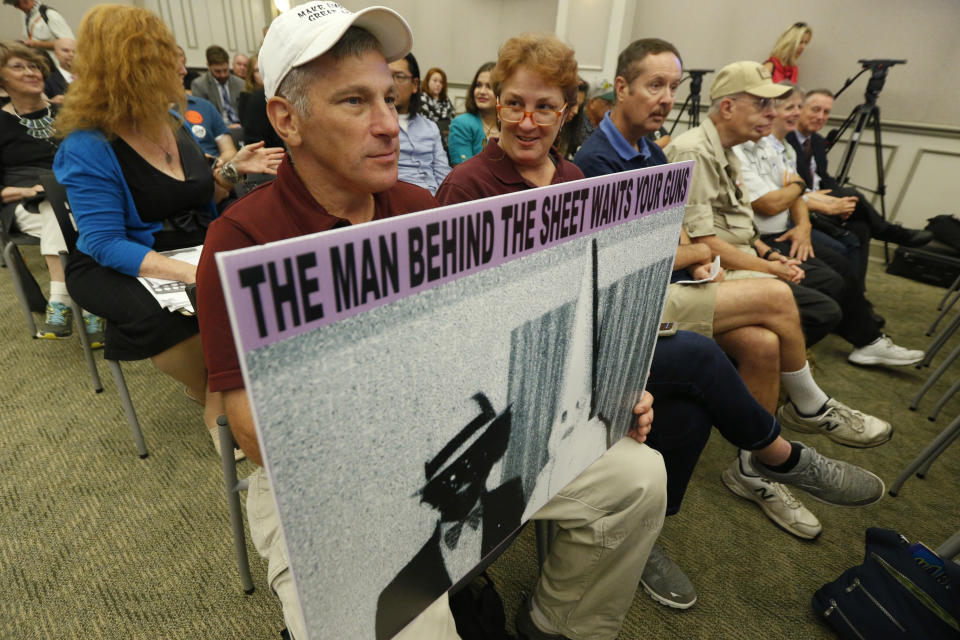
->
xmin=437 ymin=138 xmax=583 ymax=205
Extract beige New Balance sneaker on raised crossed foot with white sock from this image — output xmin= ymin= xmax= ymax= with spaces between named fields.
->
xmin=777 ymin=398 xmax=893 ymax=449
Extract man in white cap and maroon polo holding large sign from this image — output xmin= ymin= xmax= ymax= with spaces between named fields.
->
xmin=197 ymin=2 xmax=665 ymax=640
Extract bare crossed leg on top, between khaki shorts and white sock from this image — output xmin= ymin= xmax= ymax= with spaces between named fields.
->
xmin=713 ymin=278 xmax=807 ymax=372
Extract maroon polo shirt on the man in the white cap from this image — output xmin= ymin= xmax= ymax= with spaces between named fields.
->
xmin=197 ymin=157 xmax=437 ymax=391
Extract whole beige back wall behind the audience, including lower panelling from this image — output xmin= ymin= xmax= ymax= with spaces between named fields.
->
xmin=0 ymin=0 xmax=960 ymax=225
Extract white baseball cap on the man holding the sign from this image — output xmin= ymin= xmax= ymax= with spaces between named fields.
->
xmin=258 ymin=0 xmax=413 ymax=98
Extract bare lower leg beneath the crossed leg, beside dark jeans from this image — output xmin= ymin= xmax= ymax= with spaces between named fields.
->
xmin=714 ymin=326 xmax=780 ymax=415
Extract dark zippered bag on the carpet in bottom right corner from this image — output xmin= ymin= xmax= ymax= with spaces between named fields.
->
xmin=811 ymin=527 xmax=960 ymax=640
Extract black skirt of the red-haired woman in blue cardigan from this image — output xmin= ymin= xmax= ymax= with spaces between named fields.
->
xmin=66 ymin=250 xmax=200 ymax=360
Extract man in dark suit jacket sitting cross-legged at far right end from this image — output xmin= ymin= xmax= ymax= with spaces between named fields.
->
xmin=787 ymin=89 xmax=933 ymax=282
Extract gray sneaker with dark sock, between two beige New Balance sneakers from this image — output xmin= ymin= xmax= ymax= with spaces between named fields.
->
xmin=751 ymin=446 xmax=884 ymax=507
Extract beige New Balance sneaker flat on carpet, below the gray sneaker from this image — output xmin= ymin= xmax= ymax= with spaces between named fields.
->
xmin=720 ymin=456 xmax=823 ymax=540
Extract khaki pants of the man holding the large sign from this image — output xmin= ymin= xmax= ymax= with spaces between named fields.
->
xmin=247 ymin=438 xmax=667 ymax=640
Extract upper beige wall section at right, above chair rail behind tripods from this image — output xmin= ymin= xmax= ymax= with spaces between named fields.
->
xmin=633 ymin=0 xmax=960 ymax=126
